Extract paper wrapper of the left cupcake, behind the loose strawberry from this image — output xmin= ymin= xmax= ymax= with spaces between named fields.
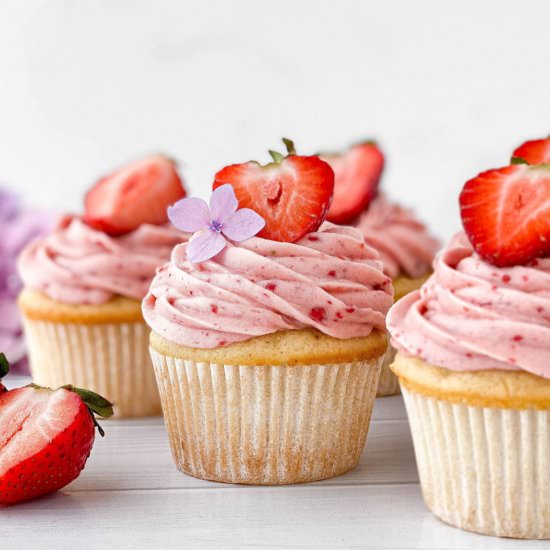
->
xmin=24 ymin=319 xmax=162 ymax=418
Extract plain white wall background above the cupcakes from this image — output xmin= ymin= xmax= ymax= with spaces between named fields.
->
xmin=0 ymin=0 xmax=550 ymax=242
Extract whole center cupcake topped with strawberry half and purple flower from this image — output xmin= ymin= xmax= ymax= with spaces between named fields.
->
xmin=143 ymin=142 xmax=392 ymax=485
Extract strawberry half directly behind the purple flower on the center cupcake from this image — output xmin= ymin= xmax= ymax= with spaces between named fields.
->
xmin=213 ymin=139 xmax=334 ymax=242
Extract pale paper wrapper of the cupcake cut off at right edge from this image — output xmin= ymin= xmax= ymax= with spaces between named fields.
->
xmin=401 ymin=387 xmax=550 ymax=539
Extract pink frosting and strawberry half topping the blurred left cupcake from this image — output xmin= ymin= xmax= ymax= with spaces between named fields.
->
xmin=19 ymin=156 xmax=185 ymax=305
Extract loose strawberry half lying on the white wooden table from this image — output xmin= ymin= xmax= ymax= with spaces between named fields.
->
xmin=0 ymin=368 xmax=113 ymax=505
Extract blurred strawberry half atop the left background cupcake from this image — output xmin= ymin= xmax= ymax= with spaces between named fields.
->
xmin=84 ymin=155 xmax=185 ymax=235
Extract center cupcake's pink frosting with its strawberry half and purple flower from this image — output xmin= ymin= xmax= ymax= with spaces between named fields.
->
xmin=143 ymin=140 xmax=393 ymax=349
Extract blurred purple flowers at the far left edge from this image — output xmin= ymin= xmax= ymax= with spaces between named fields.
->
xmin=0 ymin=188 xmax=53 ymax=373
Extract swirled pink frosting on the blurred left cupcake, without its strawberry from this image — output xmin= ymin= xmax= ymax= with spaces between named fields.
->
xmin=19 ymin=218 xmax=184 ymax=304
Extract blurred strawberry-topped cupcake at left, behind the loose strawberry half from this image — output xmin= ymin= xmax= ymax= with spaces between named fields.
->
xmin=18 ymin=156 xmax=185 ymax=417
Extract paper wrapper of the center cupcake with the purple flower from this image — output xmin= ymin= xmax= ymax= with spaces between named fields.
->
xmin=151 ymin=349 xmax=382 ymax=485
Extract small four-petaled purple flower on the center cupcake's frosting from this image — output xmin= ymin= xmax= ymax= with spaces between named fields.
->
xmin=168 ymin=183 xmax=265 ymax=264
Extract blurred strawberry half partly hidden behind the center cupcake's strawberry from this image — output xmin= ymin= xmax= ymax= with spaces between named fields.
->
xmin=321 ymin=142 xmax=384 ymax=224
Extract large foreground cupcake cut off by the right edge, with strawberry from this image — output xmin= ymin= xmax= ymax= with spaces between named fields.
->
xmin=388 ymin=144 xmax=550 ymax=539
